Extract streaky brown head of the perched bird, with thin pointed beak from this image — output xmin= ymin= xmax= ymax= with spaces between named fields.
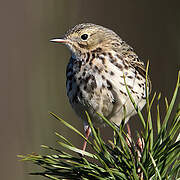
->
xmin=51 ymin=23 xmax=120 ymax=57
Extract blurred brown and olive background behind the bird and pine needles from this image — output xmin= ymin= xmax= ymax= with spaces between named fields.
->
xmin=0 ymin=0 xmax=180 ymax=180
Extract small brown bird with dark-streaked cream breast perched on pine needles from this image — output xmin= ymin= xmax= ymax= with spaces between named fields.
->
xmin=50 ymin=23 xmax=151 ymax=151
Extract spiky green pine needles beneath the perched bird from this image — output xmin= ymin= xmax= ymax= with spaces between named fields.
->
xmin=19 ymin=72 xmax=180 ymax=180
